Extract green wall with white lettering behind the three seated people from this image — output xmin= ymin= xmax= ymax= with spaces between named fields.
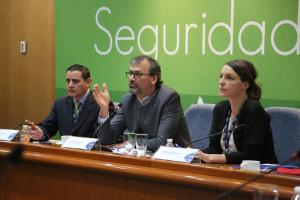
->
xmin=55 ymin=0 xmax=300 ymax=108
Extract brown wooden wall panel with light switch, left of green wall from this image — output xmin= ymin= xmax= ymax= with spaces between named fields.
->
xmin=0 ymin=0 xmax=55 ymax=128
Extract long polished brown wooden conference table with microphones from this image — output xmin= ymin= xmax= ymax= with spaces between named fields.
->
xmin=0 ymin=141 xmax=300 ymax=200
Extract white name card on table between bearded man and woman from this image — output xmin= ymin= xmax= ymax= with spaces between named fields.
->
xmin=152 ymin=146 xmax=199 ymax=163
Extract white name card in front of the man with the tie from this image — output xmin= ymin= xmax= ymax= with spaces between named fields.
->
xmin=61 ymin=136 xmax=98 ymax=150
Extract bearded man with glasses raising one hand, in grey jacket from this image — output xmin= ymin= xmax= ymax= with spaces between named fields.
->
xmin=94 ymin=55 xmax=190 ymax=151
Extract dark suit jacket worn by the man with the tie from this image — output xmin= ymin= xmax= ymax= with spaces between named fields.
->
xmin=39 ymin=92 xmax=99 ymax=139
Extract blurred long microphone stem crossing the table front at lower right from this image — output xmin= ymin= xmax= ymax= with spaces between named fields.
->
xmin=215 ymin=150 xmax=300 ymax=200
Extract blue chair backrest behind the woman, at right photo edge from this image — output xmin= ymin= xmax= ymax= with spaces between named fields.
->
xmin=266 ymin=107 xmax=300 ymax=163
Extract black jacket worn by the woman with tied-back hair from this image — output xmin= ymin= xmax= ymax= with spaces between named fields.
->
xmin=204 ymin=99 xmax=277 ymax=163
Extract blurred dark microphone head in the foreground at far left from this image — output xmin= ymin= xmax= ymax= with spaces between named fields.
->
xmin=0 ymin=144 xmax=24 ymax=177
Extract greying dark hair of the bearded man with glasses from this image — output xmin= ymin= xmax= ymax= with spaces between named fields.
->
xmin=130 ymin=55 xmax=163 ymax=88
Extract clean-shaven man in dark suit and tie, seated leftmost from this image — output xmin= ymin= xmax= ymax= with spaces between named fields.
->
xmin=29 ymin=64 xmax=106 ymax=140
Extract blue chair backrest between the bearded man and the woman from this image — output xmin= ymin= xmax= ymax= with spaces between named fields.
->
xmin=185 ymin=104 xmax=215 ymax=149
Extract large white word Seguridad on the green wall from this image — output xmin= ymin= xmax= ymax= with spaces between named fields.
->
xmin=94 ymin=0 xmax=300 ymax=58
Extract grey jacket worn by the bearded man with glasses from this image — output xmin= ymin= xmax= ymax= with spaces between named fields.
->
xmin=99 ymin=85 xmax=190 ymax=151
